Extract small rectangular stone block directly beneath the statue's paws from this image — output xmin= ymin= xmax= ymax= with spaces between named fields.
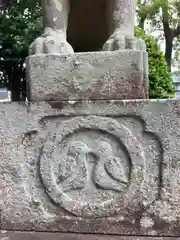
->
xmin=27 ymin=51 xmax=148 ymax=100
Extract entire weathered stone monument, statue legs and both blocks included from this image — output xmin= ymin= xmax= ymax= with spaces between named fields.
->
xmin=0 ymin=0 xmax=180 ymax=240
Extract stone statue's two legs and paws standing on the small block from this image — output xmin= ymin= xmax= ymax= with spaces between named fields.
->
xmin=29 ymin=0 xmax=146 ymax=55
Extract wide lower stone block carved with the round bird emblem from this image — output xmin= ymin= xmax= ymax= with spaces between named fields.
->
xmin=0 ymin=100 xmax=180 ymax=236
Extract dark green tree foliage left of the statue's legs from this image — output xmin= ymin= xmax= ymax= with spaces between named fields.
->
xmin=0 ymin=0 xmax=42 ymax=100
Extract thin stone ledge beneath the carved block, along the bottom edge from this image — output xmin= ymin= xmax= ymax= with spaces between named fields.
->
xmin=0 ymin=231 xmax=180 ymax=240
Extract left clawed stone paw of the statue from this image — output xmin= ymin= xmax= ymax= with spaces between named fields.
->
xmin=29 ymin=31 xmax=74 ymax=55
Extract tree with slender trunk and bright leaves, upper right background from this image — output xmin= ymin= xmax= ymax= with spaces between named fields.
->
xmin=138 ymin=0 xmax=180 ymax=71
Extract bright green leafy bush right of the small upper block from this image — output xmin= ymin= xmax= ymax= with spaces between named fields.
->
xmin=136 ymin=27 xmax=175 ymax=99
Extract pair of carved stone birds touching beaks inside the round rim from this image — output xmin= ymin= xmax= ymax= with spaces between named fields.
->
xmin=57 ymin=141 xmax=128 ymax=192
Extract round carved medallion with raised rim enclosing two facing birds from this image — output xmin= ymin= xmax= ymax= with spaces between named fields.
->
xmin=40 ymin=116 xmax=144 ymax=217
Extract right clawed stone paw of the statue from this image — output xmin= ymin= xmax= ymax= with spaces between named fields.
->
xmin=103 ymin=31 xmax=146 ymax=51
